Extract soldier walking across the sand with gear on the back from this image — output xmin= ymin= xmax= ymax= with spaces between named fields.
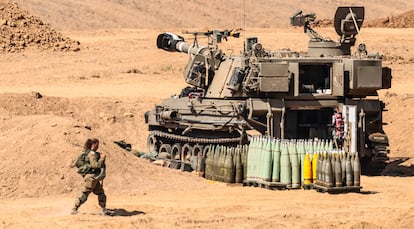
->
xmin=72 ymin=138 xmax=111 ymax=215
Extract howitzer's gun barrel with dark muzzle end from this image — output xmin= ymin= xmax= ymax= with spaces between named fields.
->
xmin=157 ymin=33 xmax=199 ymax=54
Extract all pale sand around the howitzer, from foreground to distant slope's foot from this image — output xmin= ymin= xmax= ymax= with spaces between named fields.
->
xmin=0 ymin=9 xmax=414 ymax=228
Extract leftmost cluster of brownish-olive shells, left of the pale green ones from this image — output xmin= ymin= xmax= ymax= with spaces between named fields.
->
xmin=204 ymin=145 xmax=249 ymax=183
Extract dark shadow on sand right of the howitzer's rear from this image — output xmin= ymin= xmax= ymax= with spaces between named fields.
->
xmin=381 ymin=157 xmax=414 ymax=177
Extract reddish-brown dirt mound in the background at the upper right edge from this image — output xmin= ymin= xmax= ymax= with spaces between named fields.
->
xmin=366 ymin=10 xmax=414 ymax=28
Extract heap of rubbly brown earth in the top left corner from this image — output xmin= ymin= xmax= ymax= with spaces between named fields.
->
xmin=0 ymin=1 xmax=80 ymax=52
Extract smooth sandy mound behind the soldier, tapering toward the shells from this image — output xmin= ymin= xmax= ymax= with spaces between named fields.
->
xmin=0 ymin=93 xmax=208 ymax=199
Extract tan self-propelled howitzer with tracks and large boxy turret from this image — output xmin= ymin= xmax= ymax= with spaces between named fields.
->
xmin=145 ymin=7 xmax=391 ymax=172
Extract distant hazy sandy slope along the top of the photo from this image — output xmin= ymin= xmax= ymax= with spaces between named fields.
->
xmin=15 ymin=0 xmax=414 ymax=31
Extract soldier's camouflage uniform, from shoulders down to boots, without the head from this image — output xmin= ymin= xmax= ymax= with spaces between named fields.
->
xmin=72 ymin=150 xmax=107 ymax=214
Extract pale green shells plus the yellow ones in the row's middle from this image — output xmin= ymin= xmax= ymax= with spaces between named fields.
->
xmin=246 ymin=136 xmax=352 ymax=189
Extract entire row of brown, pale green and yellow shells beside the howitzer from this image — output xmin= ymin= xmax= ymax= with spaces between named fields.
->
xmin=204 ymin=136 xmax=361 ymax=189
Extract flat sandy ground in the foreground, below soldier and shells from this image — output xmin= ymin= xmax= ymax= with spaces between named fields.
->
xmin=0 ymin=177 xmax=414 ymax=228
